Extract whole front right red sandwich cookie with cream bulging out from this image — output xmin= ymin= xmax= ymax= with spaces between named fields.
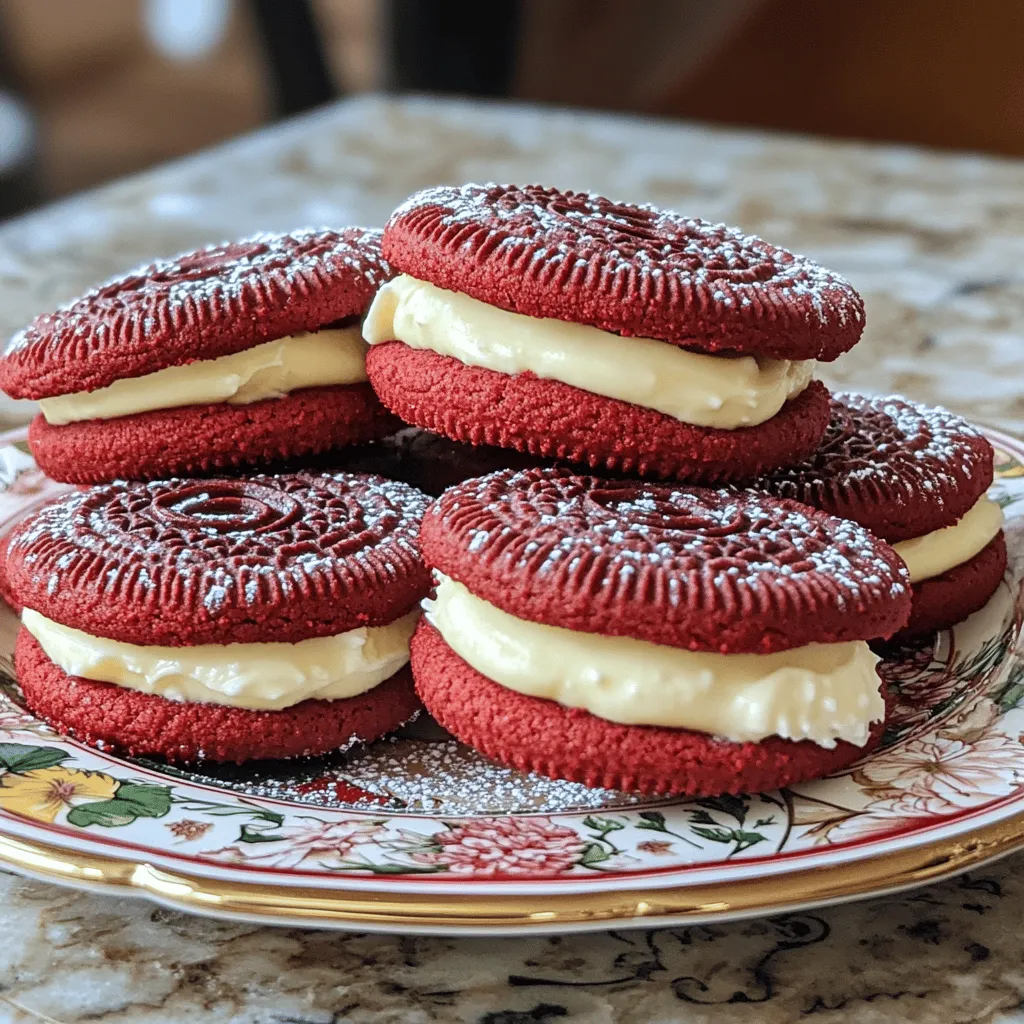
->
xmin=412 ymin=469 xmax=910 ymax=796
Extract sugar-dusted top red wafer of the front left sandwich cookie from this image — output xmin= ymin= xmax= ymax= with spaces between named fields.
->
xmin=6 ymin=473 xmax=429 ymax=646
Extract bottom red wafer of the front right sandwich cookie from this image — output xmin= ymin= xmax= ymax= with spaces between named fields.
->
xmin=412 ymin=622 xmax=884 ymax=797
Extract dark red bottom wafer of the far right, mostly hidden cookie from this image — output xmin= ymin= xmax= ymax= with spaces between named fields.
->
xmin=893 ymin=530 xmax=1007 ymax=642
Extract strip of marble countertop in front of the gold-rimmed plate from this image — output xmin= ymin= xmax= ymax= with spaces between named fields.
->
xmin=6 ymin=857 xmax=1024 ymax=1024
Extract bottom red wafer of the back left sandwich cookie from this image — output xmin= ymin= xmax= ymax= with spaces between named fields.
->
xmin=29 ymin=383 xmax=401 ymax=483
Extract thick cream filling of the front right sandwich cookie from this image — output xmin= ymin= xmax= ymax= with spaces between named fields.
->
xmin=424 ymin=577 xmax=885 ymax=746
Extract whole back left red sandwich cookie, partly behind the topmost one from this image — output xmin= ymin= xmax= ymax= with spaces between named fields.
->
xmin=0 ymin=227 xmax=397 ymax=483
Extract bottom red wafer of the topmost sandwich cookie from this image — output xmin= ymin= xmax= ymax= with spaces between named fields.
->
xmin=367 ymin=341 xmax=831 ymax=483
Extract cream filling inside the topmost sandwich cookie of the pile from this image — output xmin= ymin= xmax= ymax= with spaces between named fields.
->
xmin=362 ymin=274 xmax=814 ymax=430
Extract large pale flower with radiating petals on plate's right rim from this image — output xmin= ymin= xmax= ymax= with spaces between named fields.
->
xmin=858 ymin=733 xmax=1024 ymax=814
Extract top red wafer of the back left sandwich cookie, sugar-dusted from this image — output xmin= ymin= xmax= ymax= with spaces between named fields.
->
xmin=0 ymin=227 xmax=390 ymax=398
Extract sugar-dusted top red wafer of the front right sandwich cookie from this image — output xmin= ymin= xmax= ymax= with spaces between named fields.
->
xmin=420 ymin=469 xmax=910 ymax=653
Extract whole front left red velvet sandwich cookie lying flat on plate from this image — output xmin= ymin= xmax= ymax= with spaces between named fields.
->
xmin=6 ymin=473 xmax=429 ymax=762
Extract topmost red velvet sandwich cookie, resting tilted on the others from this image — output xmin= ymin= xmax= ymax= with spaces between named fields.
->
xmin=364 ymin=184 xmax=863 ymax=482
